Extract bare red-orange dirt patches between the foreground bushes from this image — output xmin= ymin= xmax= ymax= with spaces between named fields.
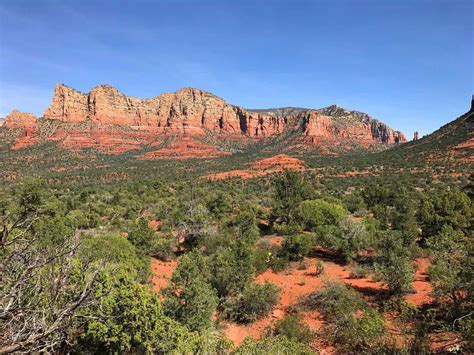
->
xmin=152 ymin=254 xmax=431 ymax=354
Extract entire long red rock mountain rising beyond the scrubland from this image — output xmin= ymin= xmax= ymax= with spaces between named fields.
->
xmin=4 ymin=84 xmax=406 ymax=159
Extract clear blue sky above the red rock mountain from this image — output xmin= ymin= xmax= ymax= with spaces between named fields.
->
xmin=0 ymin=0 xmax=474 ymax=138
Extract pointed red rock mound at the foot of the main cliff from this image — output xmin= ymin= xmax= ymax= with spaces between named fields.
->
xmin=138 ymin=137 xmax=230 ymax=160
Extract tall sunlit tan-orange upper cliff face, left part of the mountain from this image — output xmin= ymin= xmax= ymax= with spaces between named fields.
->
xmin=44 ymin=85 xmax=283 ymax=137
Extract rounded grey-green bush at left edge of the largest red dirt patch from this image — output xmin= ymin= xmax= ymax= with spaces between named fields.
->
xmin=223 ymin=282 xmax=280 ymax=323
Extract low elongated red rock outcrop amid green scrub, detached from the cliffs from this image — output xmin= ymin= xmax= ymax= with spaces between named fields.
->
xmin=206 ymin=154 xmax=305 ymax=180
